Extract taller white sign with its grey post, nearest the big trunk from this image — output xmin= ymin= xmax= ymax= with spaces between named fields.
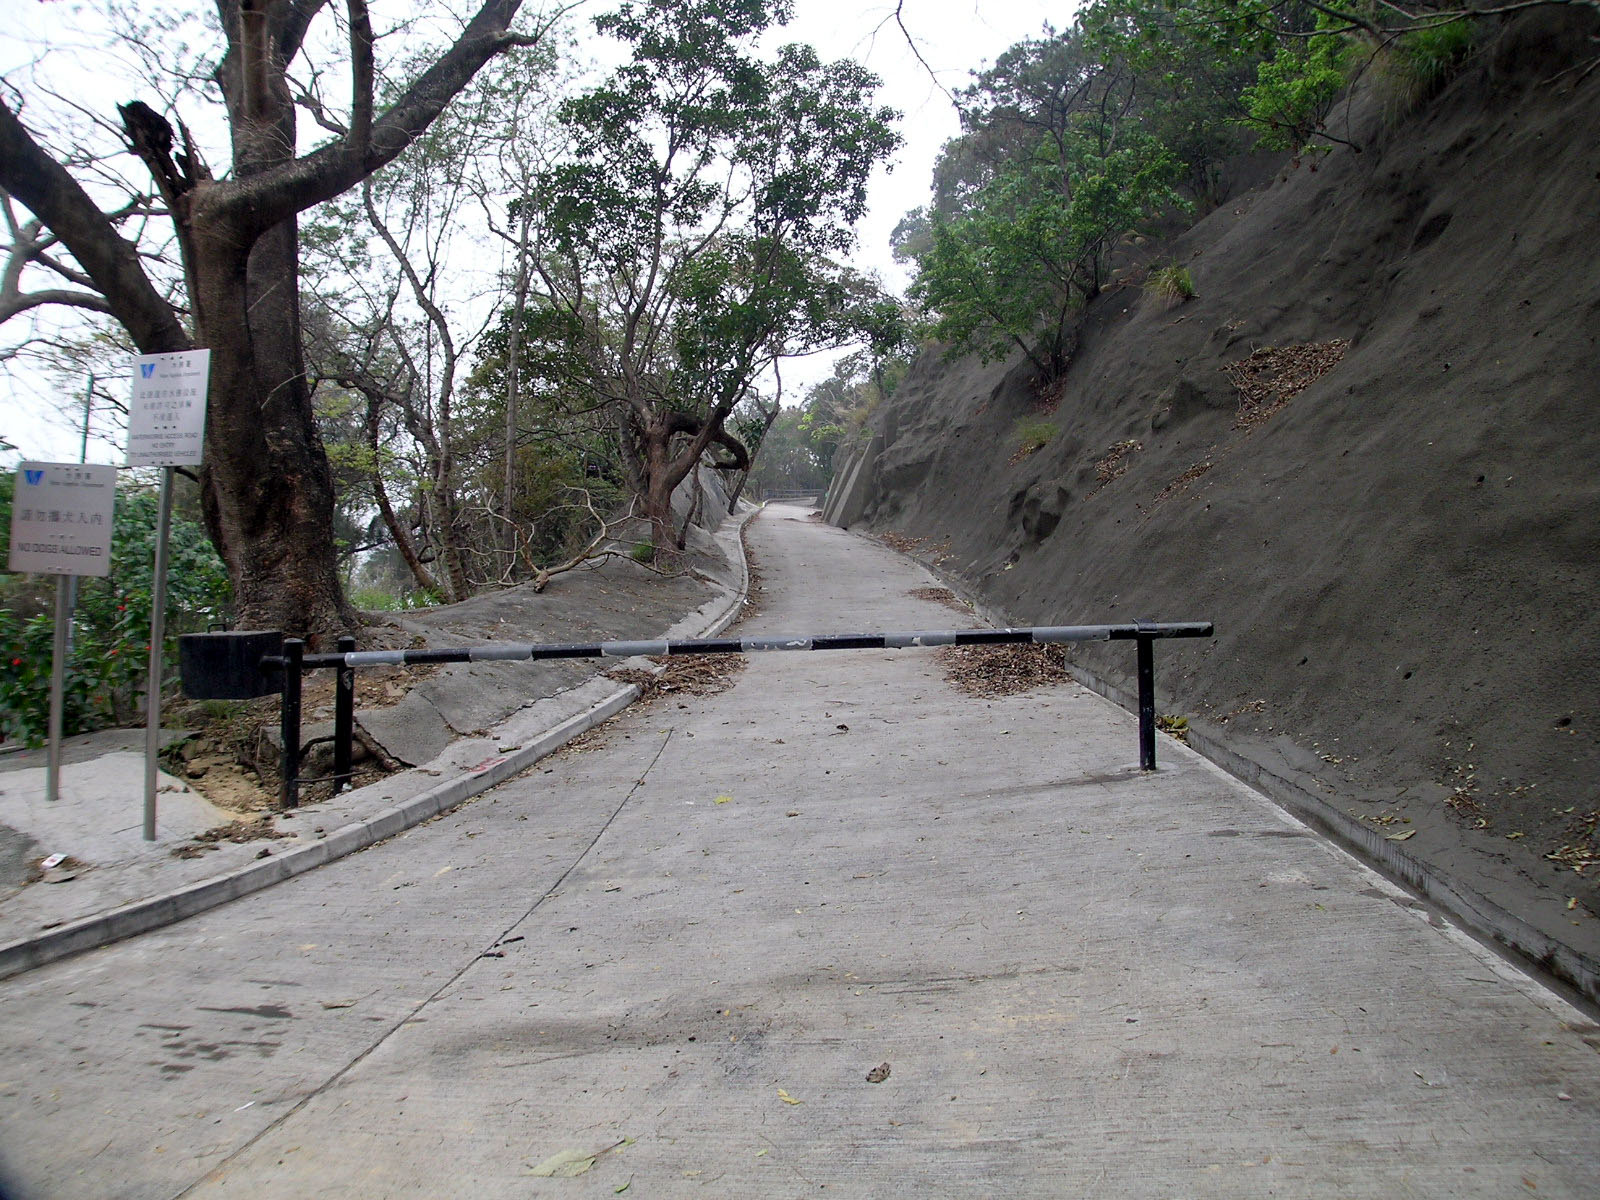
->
xmin=128 ymin=350 xmax=211 ymax=842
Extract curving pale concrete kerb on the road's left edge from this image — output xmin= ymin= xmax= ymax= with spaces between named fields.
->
xmin=0 ymin=509 xmax=760 ymax=979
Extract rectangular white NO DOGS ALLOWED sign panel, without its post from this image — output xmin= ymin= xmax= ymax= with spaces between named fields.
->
xmin=10 ymin=462 xmax=117 ymax=576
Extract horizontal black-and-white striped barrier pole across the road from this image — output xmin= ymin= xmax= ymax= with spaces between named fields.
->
xmin=291 ymin=621 xmax=1213 ymax=670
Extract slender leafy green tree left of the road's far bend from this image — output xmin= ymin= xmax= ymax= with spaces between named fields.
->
xmin=524 ymin=0 xmax=899 ymax=555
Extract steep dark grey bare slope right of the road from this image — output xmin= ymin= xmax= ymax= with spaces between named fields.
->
xmin=829 ymin=11 xmax=1600 ymax=997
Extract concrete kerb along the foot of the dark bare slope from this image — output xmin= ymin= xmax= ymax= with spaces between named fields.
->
xmin=936 ymin=585 xmax=1600 ymax=1006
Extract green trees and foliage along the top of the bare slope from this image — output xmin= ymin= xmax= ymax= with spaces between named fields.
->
xmin=893 ymin=0 xmax=1401 ymax=376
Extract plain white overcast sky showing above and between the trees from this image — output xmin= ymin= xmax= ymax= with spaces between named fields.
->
xmin=0 ymin=0 xmax=1075 ymax=462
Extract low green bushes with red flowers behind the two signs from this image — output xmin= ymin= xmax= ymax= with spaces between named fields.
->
xmin=0 ymin=472 xmax=229 ymax=746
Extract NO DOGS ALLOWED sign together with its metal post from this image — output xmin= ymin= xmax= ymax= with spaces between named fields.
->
xmin=10 ymin=462 xmax=117 ymax=800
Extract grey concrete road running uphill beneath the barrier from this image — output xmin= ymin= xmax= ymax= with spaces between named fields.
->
xmin=0 ymin=510 xmax=1600 ymax=1197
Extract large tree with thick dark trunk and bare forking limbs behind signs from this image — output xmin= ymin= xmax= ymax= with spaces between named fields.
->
xmin=0 ymin=0 xmax=563 ymax=635
